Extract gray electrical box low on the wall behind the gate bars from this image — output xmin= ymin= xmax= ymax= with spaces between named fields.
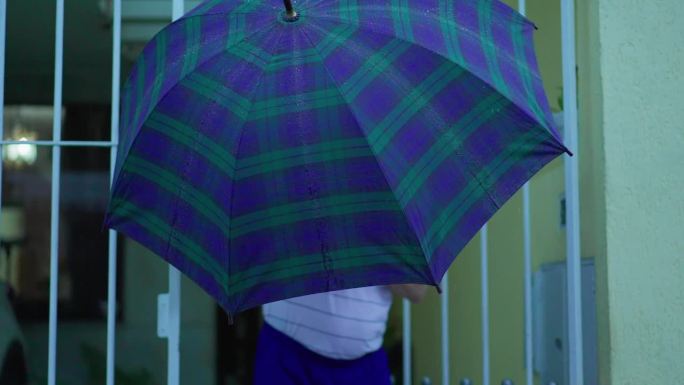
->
xmin=532 ymin=258 xmax=598 ymax=385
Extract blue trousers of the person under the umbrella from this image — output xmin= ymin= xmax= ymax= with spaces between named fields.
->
xmin=254 ymin=323 xmax=390 ymax=385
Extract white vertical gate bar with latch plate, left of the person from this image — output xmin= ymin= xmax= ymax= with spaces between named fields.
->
xmin=168 ymin=0 xmax=184 ymax=385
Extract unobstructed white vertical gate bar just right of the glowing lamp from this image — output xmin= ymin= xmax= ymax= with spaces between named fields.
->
xmin=48 ymin=0 xmax=64 ymax=385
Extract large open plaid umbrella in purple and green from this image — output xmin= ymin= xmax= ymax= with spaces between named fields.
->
xmin=106 ymin=0 xmax=567 ymax=314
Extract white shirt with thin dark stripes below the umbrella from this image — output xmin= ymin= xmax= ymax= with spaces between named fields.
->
xmin=263 ymin=286 xmax=392 ymax=360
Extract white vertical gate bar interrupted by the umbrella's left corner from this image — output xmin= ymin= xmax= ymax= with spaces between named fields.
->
xmin=106 ymin=0 xmax=121 ymax=385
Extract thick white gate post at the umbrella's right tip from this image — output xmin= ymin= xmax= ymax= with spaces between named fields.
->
xmin=561 ymin=0 xmax=584 ymax=385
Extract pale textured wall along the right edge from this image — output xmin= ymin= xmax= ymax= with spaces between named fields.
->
xmin=598 ymin=0 xmax=684 ymax=385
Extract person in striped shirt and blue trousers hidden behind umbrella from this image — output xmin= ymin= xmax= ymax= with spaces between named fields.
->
xmin=254 ymin=284 xmax=427 ymax=385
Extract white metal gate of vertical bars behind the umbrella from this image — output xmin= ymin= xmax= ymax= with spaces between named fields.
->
xmin=0 ymin=0 xmax=584 ymax=385
